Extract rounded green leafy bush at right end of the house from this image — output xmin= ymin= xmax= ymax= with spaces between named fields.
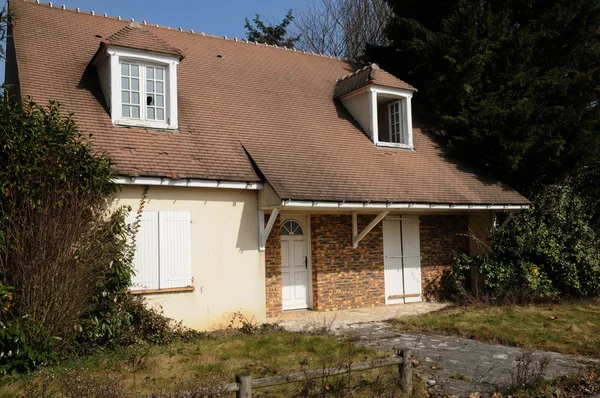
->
xmin=453 ymin=182 xmax=600 ymax=300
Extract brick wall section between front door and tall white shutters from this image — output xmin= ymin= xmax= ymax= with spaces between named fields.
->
xmin=310 ymin=215 xmax=385 ymax=311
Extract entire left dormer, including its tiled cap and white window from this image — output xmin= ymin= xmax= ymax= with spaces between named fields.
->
xmin=94 ymin=23 xmax=183 ymax=129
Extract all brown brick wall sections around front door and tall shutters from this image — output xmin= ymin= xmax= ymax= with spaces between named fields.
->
xmin=265 ymin=214 xmax=469 ymax=317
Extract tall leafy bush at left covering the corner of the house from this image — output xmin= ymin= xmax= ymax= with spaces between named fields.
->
xmin=0 ymin=98 xmax=192 ymax=373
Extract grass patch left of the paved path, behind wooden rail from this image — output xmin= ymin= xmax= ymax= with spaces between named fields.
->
xmin=0 ymin=331 xmax=404 ymax=398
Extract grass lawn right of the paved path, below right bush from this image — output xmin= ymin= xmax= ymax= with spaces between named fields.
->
xmin=393 ymin=300 xmax=600 ymax=358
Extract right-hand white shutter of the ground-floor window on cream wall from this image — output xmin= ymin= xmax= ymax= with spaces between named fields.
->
xmin=158 ymin=211 xmax=192 ymax=289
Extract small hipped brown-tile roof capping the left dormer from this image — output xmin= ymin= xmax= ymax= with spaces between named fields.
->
xmin=101 ymin=22 xmax=183 ymax=60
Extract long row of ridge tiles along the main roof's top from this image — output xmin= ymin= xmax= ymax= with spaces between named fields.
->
xmin=27 ymin=0 xmax=369 ymax=66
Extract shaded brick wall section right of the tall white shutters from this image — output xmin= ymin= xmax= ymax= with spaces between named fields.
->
xmin=419 ymin=216 xmax=469 ymax=300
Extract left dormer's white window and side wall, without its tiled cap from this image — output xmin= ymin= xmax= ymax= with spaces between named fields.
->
xmin=97 ymin=45 xmax=179 ymax=130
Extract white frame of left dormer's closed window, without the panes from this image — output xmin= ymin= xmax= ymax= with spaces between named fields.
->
xmin=107 ymin=46 xmax=179 ymax=130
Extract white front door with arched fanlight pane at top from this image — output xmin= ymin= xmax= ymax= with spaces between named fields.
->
xmin=280 ymin=217 xmax=309 ymax=311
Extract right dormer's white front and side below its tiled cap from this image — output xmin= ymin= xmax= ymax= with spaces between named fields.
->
xmin=340 ymin=84 xmax=414 ymax=150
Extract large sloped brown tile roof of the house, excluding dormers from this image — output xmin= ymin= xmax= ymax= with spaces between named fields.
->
xmin=7 ymin=0 xmax=528 ymax=204
